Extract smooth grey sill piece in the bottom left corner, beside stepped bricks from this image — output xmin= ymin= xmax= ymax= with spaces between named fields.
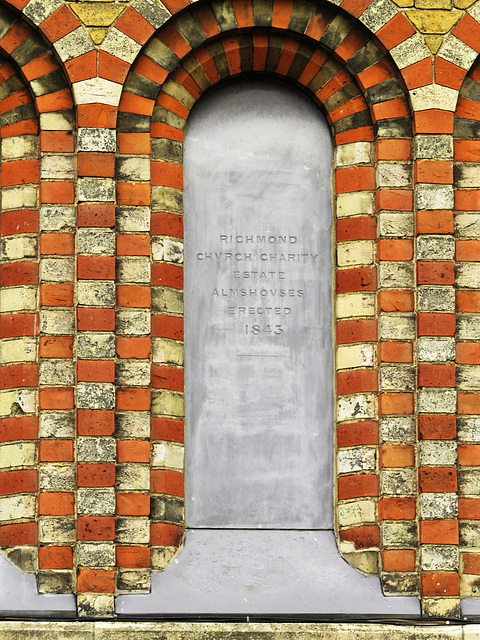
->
xmin=0 ymin=556 xmax=76 ymax=618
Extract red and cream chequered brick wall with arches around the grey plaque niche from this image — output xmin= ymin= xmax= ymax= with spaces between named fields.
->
xmin=0 ymin=0 xmax=480 ymax=617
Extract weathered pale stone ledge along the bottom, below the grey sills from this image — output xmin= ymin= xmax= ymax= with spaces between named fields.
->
xmin=0 ymin=621 xmax=480 ymax=640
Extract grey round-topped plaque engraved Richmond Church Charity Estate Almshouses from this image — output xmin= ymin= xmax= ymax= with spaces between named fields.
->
xmin=185 ymin=80 xmax=333 ymax=529
